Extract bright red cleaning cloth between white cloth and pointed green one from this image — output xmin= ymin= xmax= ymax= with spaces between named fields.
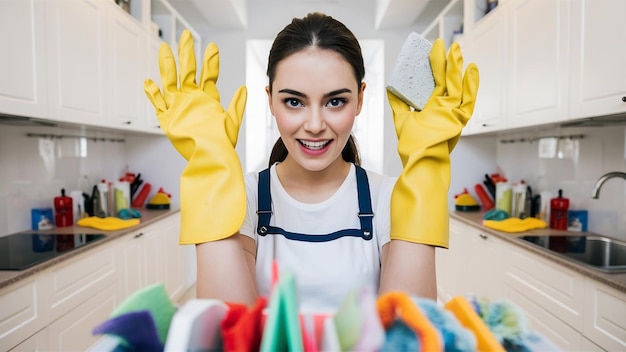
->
xmin=222 ymin=297 xmax=267 ymax=352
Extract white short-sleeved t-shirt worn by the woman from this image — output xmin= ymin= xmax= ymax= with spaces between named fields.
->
xmin=240 ymin=165 xmax=395 ymax=312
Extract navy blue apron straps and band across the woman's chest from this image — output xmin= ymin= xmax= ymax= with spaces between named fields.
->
xmin=257 ymin=165 xmax=374 ymax=242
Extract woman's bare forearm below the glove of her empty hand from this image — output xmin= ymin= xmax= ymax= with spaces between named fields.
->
xmin=196 ymin=235 xmax=258 ymax=306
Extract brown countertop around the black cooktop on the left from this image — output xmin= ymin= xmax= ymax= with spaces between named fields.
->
xmin=0 ymin=209 xmax=179 ymax=289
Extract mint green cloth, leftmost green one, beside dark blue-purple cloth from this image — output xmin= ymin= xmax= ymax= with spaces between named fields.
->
xmin=111 ymin=283 xmax=176 ymax=345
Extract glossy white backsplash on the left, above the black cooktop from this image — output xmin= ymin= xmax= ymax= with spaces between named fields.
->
xmin=0 ymin=125 xmax=179 ymax=236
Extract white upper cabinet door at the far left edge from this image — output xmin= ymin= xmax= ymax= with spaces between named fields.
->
xmin=0 ymin=0 xmax=48 ymax=118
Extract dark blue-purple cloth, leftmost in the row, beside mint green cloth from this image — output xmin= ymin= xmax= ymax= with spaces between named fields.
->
xmin=93 ymin=310 xmax=164 ymax=352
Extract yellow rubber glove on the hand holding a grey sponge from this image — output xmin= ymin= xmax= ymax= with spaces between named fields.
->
xmin=387 ymin=39 xmax=479 ymax=248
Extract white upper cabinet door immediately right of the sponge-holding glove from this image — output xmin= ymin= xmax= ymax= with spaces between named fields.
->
xmin=460 ymin=3 xmax=509 ymax=134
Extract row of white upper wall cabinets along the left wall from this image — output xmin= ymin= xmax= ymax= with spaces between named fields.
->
xmin=0 ymin=0 xmax=202 ymax=134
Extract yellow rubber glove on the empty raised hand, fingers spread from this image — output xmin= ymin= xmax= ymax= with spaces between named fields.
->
xmin=144 ymin=30 xmax=247 ymax=244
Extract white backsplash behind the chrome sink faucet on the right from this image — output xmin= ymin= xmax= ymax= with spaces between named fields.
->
xmin=493 ymin=126 xmax=626 ymax=240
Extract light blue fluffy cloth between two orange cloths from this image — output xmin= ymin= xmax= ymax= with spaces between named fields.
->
xmin=412 ymin=297 xmax=478 ymax=352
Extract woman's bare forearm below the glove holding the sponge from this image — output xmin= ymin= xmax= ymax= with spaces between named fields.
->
xmin=380 ymin=240 xmax=437 ymax=299
